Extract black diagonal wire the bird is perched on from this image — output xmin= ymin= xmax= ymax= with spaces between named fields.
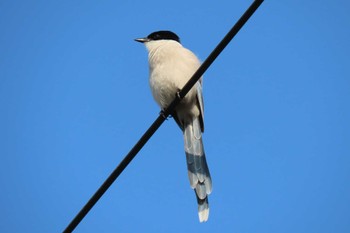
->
xmin=63 ymin=0 xmax=264 ymax=233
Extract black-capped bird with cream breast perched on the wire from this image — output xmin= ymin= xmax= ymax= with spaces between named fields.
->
xmin=135 ymin=30 xmax=212 ymax=222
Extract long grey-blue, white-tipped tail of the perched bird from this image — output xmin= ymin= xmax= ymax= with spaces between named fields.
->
xmin=184 ymin=118 xmax=212 ymax=222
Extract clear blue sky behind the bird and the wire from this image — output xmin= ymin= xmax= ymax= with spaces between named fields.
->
xmin=0 ymin=0 xmax=350 ymax=233
